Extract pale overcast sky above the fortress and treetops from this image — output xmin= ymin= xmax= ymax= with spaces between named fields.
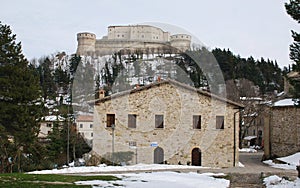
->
xmin=0 ymin=0 xmax=300 ymax=67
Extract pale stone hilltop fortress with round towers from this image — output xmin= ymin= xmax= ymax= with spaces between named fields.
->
xmin=76 ymin=25 xmax=191 ymax=55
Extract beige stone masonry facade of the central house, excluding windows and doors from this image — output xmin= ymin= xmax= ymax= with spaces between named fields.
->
xmin=93 ymin=83 xmax=239 ymax=167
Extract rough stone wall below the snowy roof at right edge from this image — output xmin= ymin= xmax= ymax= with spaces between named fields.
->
xmin=270 ymin=106 xmax=300 ymax=157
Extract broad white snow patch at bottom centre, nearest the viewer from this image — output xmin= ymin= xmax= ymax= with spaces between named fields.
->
xmin=75 ymin=172 xmax=230 ymax=188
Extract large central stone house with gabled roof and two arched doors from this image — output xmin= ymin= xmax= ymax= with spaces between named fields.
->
xmin=93 ymin=80 xmax=243 ymax=167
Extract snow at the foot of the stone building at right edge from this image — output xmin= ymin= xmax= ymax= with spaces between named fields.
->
xmin=263 ymin=152 xmax=300 ymax=170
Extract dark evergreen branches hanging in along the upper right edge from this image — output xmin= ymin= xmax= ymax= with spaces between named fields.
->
xmin=285 ymin=0 xmax=300 ymax=105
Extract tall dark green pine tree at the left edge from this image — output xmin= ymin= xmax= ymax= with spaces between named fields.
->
xmin=0 ymin=22 xmax=41 ymax=172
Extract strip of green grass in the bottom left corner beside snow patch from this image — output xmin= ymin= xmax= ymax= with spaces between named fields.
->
xmin=0 ymin=173 xmax=119 ymax=188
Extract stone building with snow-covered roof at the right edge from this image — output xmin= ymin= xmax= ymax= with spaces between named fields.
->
xmin=264 ymin=98 xmax=300 ymax=159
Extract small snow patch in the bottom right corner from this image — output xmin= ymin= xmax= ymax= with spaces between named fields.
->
xmin=264 ymin=175 xmax=300 ymax=188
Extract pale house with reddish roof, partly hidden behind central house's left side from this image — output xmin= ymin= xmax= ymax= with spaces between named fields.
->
xmin=75 ymin=115 xmax=93 ymax=143
